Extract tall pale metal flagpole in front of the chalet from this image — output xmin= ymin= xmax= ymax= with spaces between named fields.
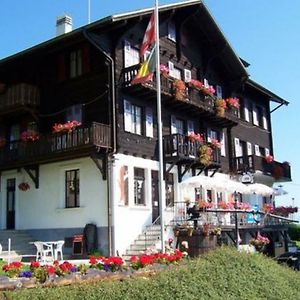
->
xmin=154 ymin=0 xmax=165 ymax=253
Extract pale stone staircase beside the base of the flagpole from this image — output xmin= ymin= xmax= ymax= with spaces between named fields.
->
xmin=122 ymin=225 xmax=161 ymax=261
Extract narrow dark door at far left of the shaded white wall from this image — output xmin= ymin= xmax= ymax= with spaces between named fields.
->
xmin=6 ymin=178 xmax=16 ymax=229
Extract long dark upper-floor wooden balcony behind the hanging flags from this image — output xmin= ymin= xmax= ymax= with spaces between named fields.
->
xmin=123 ymin=65 xmax=238 ymax=127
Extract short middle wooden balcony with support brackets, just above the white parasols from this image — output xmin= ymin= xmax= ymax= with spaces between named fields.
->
xmin=163 ymin=134 xmax=221 ymax=181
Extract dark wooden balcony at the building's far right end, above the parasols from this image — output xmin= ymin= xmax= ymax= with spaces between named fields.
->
xmin=232 ymin=155 xmax=292 ymax=182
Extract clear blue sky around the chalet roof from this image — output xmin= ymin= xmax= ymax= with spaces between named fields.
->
xmin=0 ymin=0 xmax=300 ymax=220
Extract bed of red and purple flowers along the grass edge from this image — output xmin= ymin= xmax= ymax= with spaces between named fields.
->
xmin=0 ymin=249 xmax=185 ymax=290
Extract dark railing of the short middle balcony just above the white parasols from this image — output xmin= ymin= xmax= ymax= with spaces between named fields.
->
xmin=163 ymin=134 xmax=221 ymax=166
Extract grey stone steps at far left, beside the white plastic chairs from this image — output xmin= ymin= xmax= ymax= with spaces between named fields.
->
xmin=0 ymin=230 xmax=36 ymax=261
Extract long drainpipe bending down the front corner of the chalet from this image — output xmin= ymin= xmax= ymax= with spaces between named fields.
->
xmin=83 ymin=28 xmax=117 ymax=255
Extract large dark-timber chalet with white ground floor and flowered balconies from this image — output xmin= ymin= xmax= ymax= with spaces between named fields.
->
xmin=0 ymin=1 xmax=291 ymax=254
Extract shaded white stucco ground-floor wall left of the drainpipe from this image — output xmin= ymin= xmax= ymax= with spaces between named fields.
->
xmin=0 ymin=158 xmax=108 ymax=229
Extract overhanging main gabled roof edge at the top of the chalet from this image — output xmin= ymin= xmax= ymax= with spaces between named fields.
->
xmin=0 ymin=0 xmax=249 ymax=79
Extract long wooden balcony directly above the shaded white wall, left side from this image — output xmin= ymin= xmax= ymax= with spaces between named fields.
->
xmin=0 ymin=123 xmax=111 ymax=170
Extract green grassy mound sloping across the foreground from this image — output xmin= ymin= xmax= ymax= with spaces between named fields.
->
xmin=0 ymin=247 xmax=300 ymax=300
